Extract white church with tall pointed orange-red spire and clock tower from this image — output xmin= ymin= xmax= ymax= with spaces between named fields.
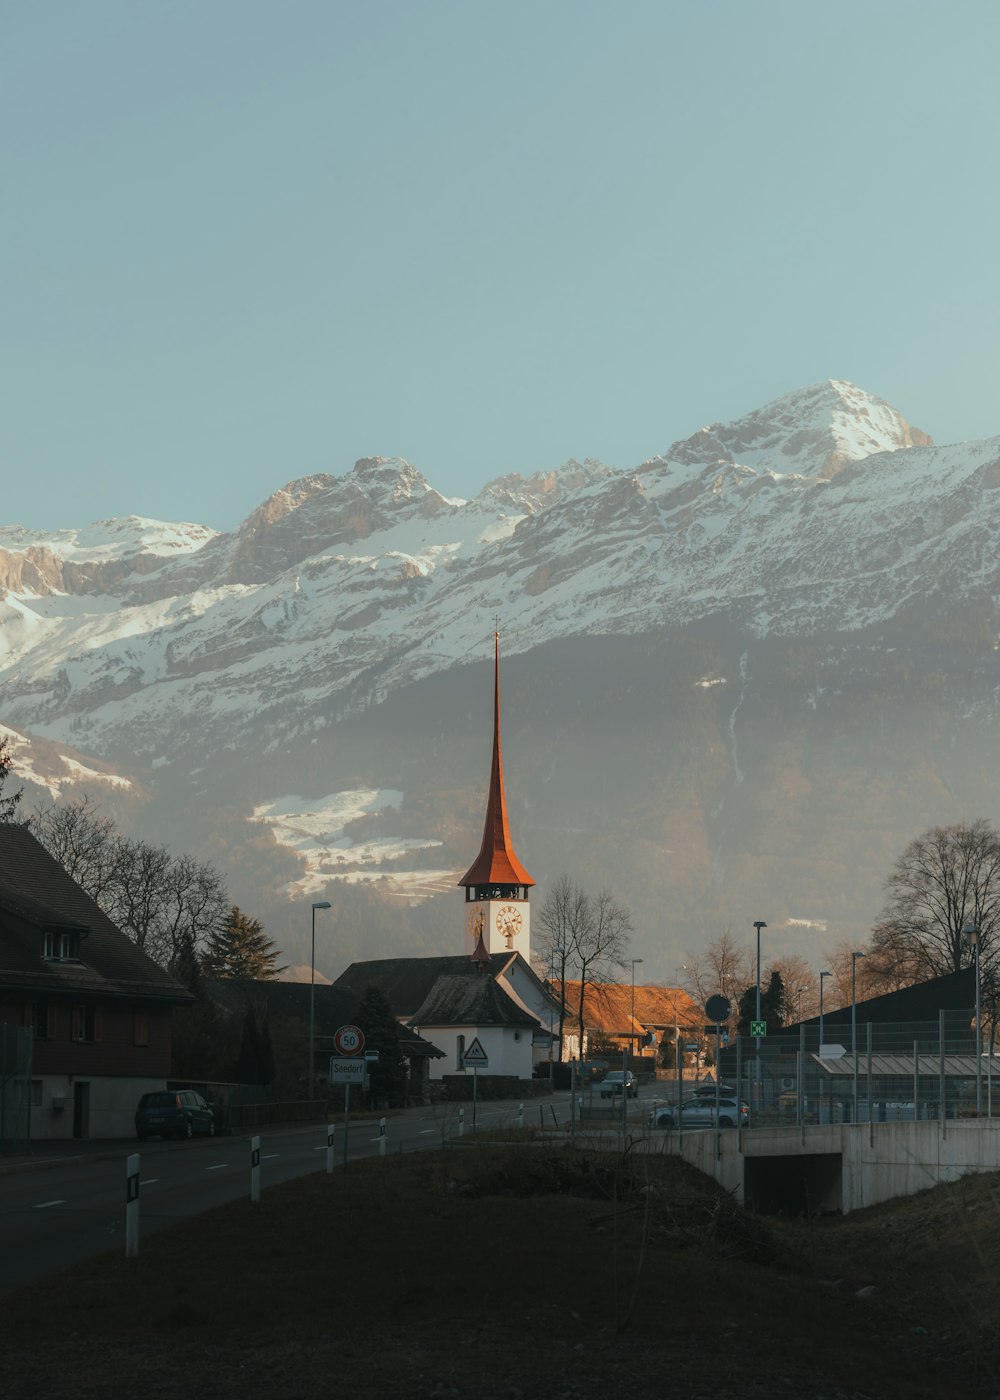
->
xmin=335 ymin=633 xmax=559 ymax=1092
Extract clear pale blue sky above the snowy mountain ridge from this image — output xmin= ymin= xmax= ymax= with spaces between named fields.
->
xmin=0 ymin=0 xmax=1000 ymax=528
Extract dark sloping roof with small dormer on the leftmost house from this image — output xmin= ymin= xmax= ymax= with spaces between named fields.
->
xmin=0 ymin=823 xmax=192 ymax=1002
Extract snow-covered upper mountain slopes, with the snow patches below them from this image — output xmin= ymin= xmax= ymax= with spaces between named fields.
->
xmin=0 ymin=381 xmax=1000 ymax=974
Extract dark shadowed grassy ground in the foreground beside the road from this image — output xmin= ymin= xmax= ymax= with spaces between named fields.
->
xmin=0 ymin=1142 xmax=1000 ymax=1400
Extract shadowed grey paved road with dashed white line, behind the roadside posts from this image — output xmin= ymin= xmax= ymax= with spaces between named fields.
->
xmin=0 ymin=1086 xmax=662 ymax=1294
